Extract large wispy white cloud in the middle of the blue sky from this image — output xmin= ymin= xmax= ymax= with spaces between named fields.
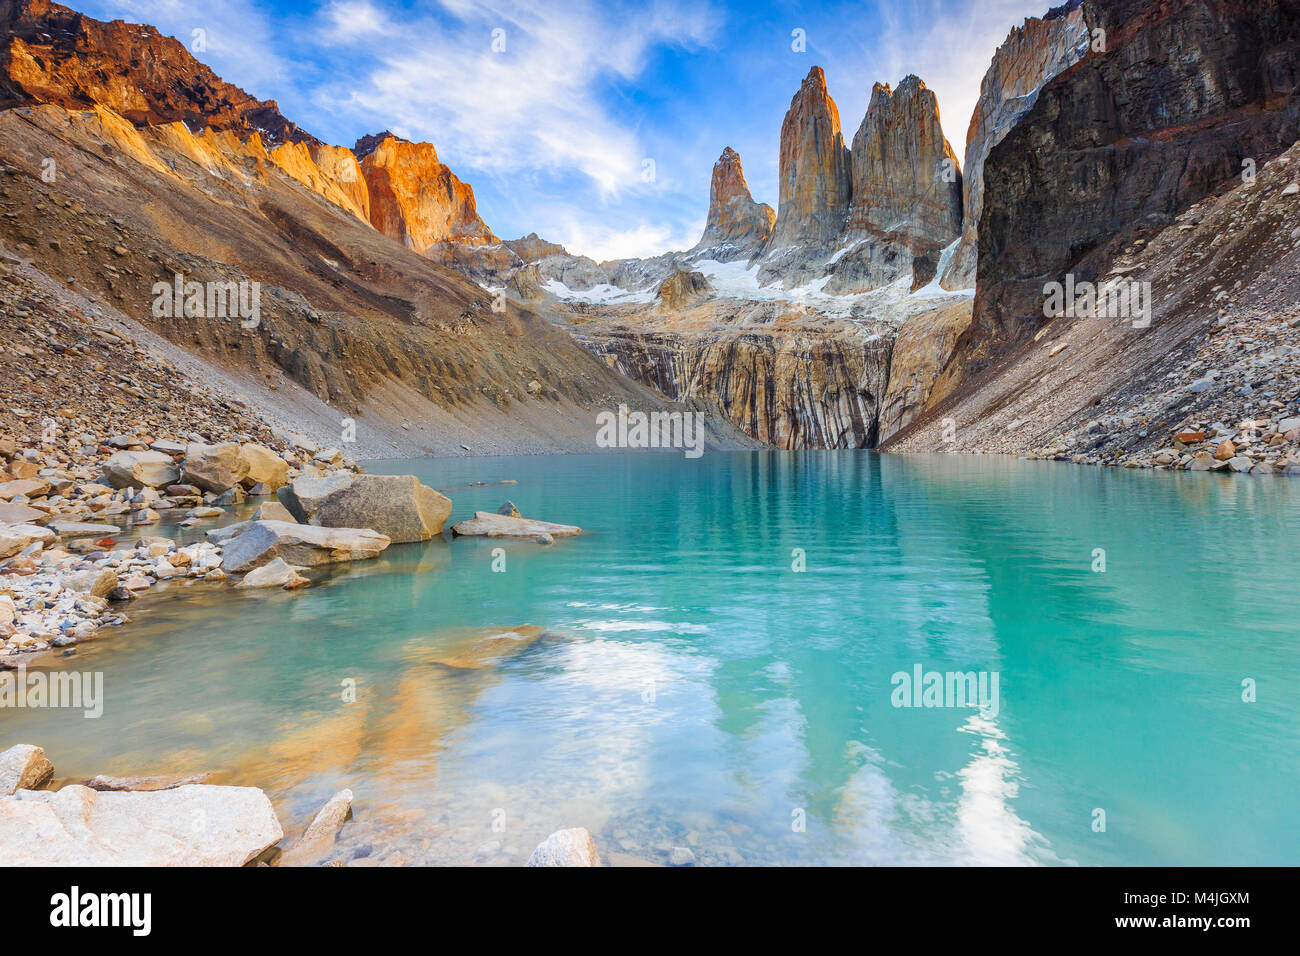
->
xmin=320 ymin=0 xmax=715 ymax=196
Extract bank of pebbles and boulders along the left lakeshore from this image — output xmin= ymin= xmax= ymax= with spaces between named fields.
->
xmin=0 ymin=429 xmax=361 ymax=666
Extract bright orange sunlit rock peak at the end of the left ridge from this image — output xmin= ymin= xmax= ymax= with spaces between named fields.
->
xmin=356 ymin=134 xmax=497 ymax=254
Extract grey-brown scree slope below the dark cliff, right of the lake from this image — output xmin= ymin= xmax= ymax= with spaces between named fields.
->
xmin=887 ymin=130 xmax=1300 ymax=470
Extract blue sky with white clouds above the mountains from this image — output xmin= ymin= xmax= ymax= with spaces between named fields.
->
xmin=81 ymin=0 xmax=1050 ymax=259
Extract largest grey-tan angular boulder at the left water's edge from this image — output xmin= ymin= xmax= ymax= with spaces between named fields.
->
xmin=280 ymin=472 xmax=451 ymax=544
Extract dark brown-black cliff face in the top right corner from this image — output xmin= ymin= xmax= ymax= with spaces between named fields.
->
xmin=975 ymin=0 xmax=1300 ymax=338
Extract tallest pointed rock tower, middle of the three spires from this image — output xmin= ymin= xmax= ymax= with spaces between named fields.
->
xmin=770 ymin=66 xmax=853 ymax=246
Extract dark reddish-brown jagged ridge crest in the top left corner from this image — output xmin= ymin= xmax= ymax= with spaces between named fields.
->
xmin=0 ymin=0 xmax=317 ymax=146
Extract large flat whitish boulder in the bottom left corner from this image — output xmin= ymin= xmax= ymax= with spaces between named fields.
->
xmin=0 ymin=784 xmax=285 ymax=866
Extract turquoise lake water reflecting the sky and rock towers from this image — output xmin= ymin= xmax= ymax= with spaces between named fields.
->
xmin=0 ymin=451 xmax=1300 ymax=865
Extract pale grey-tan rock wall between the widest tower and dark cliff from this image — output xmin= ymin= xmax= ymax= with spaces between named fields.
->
xmin=940 ymin=0 xmax=1092 ymax=289
